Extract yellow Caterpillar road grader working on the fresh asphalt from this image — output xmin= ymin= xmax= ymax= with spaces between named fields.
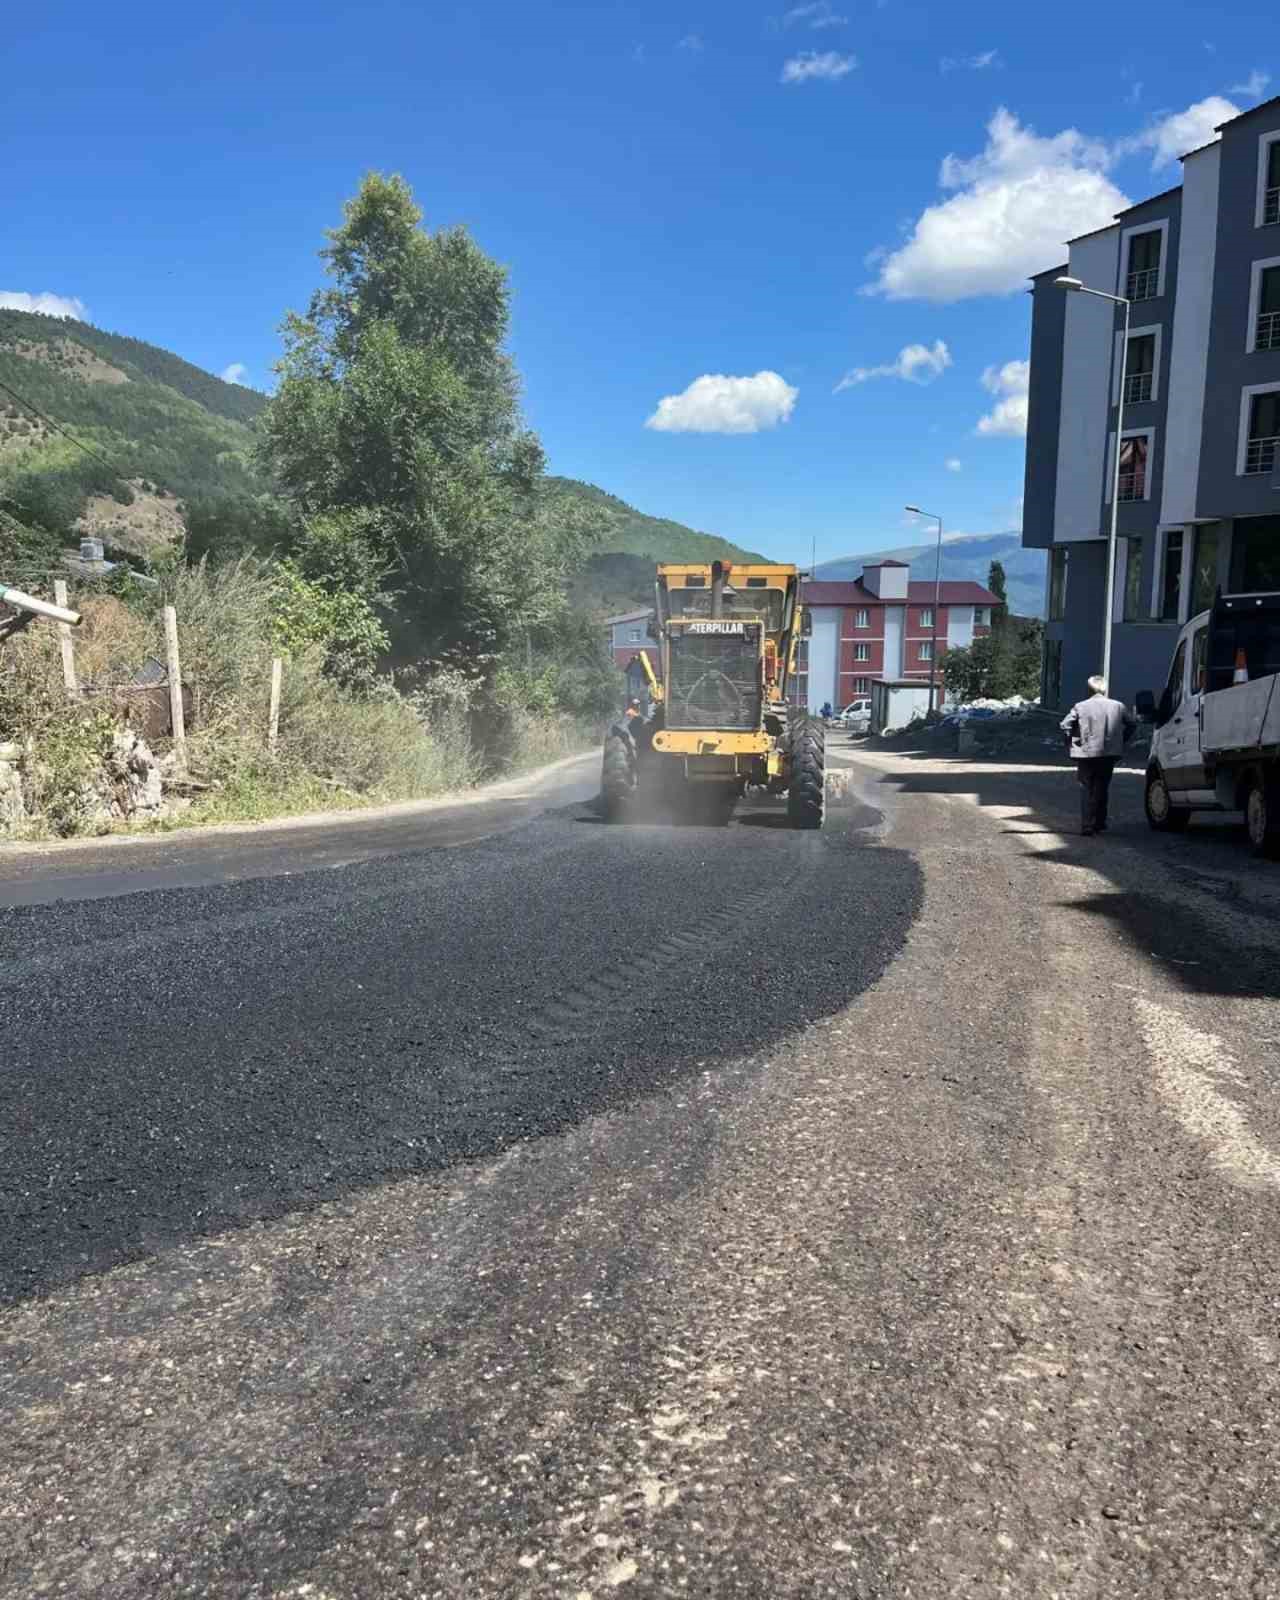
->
xmin=600 ymin=562 xmax=824 ymax=827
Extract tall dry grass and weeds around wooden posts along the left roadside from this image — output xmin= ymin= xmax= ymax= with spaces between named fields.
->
xmin=0 ymin=560 xmax=600 ymax=838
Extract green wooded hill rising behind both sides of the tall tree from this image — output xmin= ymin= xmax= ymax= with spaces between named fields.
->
xmin=0 ymin=310 xmax=758 ymax=610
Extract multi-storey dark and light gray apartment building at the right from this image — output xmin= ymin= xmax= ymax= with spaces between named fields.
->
xmin=1022 ymin=98 xmax=1280 ymax=706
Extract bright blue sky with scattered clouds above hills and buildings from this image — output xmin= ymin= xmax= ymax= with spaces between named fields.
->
xmin=0 ymin=0 xmax=1275 ymax=560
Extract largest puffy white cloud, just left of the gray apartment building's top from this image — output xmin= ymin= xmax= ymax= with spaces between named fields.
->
xmin=864 ymin=107 xmax=1128 ymax=302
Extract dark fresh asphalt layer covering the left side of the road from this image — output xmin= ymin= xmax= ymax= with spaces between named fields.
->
xmin=0 ymin=755 xmax=918 ymax=1298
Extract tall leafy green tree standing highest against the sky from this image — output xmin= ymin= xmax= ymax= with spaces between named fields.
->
xmin=261 ymin=173 xmax=604 ymax=674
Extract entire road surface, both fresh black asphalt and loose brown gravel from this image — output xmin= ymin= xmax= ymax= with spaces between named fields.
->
xmin=0 ymin=754 xmax=1280 ymax=1600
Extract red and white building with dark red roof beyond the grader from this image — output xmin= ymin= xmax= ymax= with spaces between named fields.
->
xmin=792 ymin=562 xmax=1000 ymax=712
